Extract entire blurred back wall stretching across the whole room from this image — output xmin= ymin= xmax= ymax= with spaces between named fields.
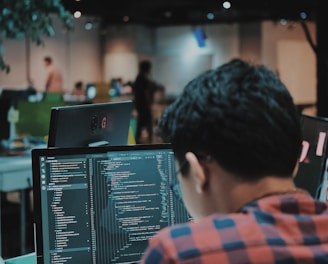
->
xmin=0 ymin=18 xmax=316 ymax=101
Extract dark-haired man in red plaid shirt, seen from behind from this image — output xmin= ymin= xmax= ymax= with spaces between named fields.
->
xmin=141 ymin=59 xmax=328 ymax=264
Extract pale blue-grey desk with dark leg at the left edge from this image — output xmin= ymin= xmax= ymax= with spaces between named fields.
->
xmin=0 ymin=152 xmax=33 ymax=256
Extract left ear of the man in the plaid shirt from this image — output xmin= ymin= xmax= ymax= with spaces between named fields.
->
xmin=185 ymin=152 xmax=206 ymax=193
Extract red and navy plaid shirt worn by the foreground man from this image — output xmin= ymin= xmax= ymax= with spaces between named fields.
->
xmin=141 ymin=193 xmax=328 ymax=264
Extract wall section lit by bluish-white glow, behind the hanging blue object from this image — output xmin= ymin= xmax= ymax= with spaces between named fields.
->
xmin=153 ymin=24 xmax=239 ymax=95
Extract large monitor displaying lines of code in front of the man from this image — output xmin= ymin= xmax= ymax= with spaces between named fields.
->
xmin=32 ymin=144 xmax=192 ymax=264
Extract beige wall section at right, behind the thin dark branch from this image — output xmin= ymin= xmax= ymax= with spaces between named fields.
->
xmin=262 ymin=22 xmax=317 ymax=104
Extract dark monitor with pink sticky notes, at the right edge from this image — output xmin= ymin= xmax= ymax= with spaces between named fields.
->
xmin=294 ymin=114 xmax=328 ymax=198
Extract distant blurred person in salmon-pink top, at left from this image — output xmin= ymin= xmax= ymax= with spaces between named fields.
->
xmin=43 ymin=56 xmax=64 ymax=93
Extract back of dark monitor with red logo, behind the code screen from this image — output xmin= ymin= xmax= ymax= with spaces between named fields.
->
xmin=48 ymin=100 xmax=133 ymax=147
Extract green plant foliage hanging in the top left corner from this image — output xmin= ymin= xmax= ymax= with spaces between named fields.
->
xmin=0 ymin=0 xmax=73 ymax=73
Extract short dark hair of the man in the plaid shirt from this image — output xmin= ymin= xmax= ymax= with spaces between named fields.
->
xmin=158 ymin=59 xmax=302 ymax=180
